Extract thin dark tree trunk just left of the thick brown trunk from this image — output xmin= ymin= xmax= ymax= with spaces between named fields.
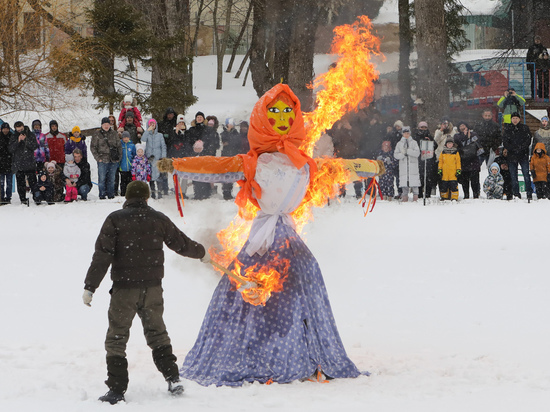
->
xmin=398 ymin=0 xmax=414 ymax=126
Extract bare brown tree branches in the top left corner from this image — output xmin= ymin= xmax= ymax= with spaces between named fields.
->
xmin=0 ymin=0 xmax=92 ymax=113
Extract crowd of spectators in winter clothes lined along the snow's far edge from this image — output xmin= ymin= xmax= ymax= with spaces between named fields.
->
xmin=0 ymin=88 xmax=550 ymax=205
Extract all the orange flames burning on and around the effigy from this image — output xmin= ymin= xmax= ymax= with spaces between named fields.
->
xmin=209 ymin=16 xmax=383 ymax=305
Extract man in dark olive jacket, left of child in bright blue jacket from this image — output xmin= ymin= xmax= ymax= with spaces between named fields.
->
xmin=90 ymin=117 xmax=122 ymax=199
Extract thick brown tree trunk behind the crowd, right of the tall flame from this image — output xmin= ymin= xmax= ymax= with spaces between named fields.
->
xmin=415 ymin=0 xmax=449 ymax=129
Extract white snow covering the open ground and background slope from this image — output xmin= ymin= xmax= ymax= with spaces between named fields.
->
xmin=0 ymin=53 xmax=550 ymax=412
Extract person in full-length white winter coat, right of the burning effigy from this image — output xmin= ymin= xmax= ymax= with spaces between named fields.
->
xmin=393 ymin=126 xmax=420 ymax=202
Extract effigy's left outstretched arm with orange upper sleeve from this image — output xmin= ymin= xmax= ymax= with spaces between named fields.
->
xmin=158 ymin=156 xmax=244 ymax=183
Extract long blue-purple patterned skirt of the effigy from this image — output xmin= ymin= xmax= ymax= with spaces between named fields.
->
xmin=180 ymin=219 xmax=360 ymax=386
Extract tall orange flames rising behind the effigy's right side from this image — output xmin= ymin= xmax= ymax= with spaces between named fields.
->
xmin=292 ymin=16 xmax=383 ymax=233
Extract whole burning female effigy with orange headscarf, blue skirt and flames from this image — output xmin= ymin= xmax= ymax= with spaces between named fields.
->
xmin=158 ymin=18 xmax=384 ymax=386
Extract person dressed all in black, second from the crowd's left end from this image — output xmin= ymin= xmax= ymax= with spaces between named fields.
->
xmin=9 ymin=122 xmax=38 ymax=206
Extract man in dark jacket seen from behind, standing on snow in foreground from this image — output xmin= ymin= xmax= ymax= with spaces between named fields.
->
xmin=82 ymin=181 xmax=210 ymax=404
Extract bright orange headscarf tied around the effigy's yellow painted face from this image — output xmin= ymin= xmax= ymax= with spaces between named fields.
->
xmin=235 ymin=83 xmax=317 ymax=208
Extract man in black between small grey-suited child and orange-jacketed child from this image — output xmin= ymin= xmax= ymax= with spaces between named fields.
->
xmin=502 ymin=113 xmax=533 ymax=199
